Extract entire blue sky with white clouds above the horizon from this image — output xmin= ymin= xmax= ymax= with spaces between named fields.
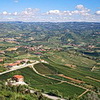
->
xmin=0 ymin=0 xmax=100 ymax=22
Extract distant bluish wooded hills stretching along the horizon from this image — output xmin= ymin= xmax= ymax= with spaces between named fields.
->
xmin=0 ymin=21 xmax=100 ymax=46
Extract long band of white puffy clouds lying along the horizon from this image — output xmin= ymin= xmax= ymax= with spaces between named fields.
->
xmin=0 ymin=5 xmax=100 ymax=22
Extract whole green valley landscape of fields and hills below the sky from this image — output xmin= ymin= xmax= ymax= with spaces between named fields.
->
xmin=0 ymin=22 xmax=100 ymax=100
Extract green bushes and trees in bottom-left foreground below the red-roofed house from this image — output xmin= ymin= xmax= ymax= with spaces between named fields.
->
xmin=0 ymin=81 xmax=49 ymax=100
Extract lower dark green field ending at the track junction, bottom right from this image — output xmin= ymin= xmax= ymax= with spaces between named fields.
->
xmin=36 ymin=83 xmax=85 ymax=97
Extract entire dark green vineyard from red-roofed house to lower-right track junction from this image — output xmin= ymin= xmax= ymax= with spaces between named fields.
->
xmin=0 ymin=68 xmax=84 ymax=97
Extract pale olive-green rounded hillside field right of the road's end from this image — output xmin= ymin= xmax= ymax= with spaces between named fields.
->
xmin=48 ymin=51 xmax=96 ymax=67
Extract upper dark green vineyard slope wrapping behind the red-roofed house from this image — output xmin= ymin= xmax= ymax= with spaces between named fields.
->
xmin=0 ymin=68 xmax=58 ymax=86
